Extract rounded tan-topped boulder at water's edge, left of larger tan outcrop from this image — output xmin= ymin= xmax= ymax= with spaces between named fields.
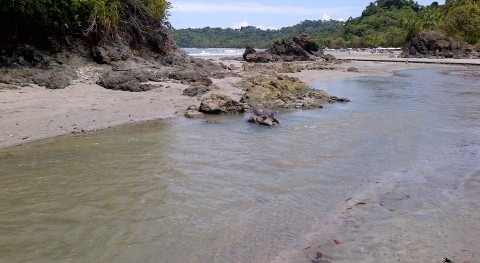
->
xmin=199 ymin=94 xmax=245 ymax=114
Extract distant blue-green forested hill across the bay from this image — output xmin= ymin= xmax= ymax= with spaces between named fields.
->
xmin=173 ymin=20 xmax=345 ymax=48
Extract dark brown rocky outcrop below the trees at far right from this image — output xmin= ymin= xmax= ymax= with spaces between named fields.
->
xmin=400 ymin=31 xmax=480 ymax=59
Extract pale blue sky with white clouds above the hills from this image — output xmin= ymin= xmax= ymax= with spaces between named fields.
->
xmin=169 ymin=0 xmax=445 ymax=29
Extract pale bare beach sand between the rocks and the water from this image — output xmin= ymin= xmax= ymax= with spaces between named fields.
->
xmin=0 ymin=54 xmax=472 ymax=149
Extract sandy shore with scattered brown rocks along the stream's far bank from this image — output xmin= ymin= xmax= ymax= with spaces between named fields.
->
xmin=0 ymin=33 xmax=466 ymax=148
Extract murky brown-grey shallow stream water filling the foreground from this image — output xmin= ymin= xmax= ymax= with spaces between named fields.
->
xmin=0 ymin=69 xmax=480 ymax=262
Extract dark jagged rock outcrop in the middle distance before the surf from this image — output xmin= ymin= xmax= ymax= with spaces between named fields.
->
xmin=243 ymin=34 xmax=323 ymax=63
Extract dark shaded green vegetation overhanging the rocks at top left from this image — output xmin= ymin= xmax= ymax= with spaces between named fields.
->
xmin=0 ymin=0 xmax=170 ymax=51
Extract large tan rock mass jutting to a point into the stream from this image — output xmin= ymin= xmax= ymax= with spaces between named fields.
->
xmin=241 ymin=75 xmax=348 ymax=109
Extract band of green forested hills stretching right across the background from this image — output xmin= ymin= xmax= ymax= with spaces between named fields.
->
xmin=174 ymin=0 xmax=480 ymax=48
